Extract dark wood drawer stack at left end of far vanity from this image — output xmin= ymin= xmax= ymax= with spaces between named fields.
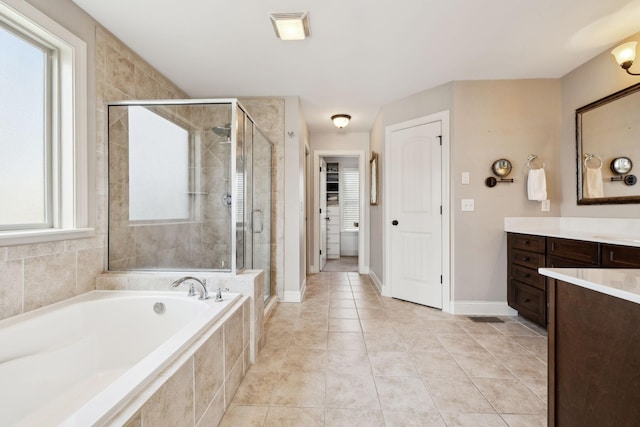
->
xmin=507 ymin=233 xmax=547 ymax=327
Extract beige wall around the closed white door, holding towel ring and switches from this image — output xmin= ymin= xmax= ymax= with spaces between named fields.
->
xmin=370 ymin=80 xmax=560 ymax=309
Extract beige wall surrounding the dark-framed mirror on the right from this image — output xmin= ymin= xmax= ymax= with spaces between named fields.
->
xmin=561 ymin=33 xmax=640 ymax=218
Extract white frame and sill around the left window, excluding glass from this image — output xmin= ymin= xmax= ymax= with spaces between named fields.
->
xmin=0 ymin=0 xmax=95 ymax=246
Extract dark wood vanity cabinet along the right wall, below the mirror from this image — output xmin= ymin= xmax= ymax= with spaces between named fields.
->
xmin=507 ymin=233 xmax=640 ymax=328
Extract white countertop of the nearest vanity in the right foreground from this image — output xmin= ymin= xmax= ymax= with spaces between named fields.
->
xmin=538 ymin=268 xmax=640 ymax=304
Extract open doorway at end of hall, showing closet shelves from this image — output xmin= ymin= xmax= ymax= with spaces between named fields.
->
xmin=311 ymin=152 xmax=366 ymax=273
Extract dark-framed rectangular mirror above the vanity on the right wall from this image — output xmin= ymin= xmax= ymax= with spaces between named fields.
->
xmin=576 ymin=83 xmax=640 ymax=205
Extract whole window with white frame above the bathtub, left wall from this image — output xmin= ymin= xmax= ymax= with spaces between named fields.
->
xmin=0 ymin=0 xmax=93 ymax=245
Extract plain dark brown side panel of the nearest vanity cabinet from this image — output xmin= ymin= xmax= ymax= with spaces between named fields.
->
xmin=548 ymin=280 xmax=640 ymax=427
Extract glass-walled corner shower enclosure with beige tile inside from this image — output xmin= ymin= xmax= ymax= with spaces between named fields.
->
xmin=107 ymin=99 xmax=272 ymax=299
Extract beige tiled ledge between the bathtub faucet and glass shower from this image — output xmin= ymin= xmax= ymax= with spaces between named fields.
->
xmin=96 ymin=270 xmax=264 ymax=362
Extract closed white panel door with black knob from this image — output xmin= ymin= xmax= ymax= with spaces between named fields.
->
xmin=387 ymin=122 xmax=442 ymax=308
